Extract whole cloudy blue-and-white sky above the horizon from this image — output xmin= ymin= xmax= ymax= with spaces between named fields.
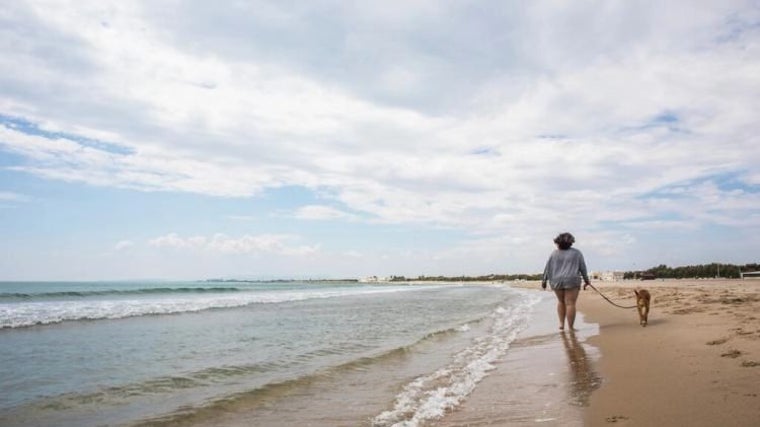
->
xmin=0 ymin=0 xmax=760 ymax=280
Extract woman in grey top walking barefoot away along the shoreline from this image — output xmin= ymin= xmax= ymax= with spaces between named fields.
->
xmin=541 ymin=233 xmax=591 ymax=330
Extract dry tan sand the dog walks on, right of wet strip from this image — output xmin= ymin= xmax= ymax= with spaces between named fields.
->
xmin=579 ymin=280 xmax=760 ymax=427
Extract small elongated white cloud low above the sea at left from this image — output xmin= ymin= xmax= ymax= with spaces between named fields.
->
xmin=148 ymin=233 xmax=319 ymax=256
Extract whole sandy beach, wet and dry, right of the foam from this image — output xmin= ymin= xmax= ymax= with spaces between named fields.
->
xmin=440 ymin=280 xmax=760 ymax=427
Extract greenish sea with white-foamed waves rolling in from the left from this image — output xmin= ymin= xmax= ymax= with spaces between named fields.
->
xmin=0 ymin=282 xmax=545 ymax=426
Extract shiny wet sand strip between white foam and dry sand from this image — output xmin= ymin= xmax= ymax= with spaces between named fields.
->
xmin=440 ymin=293 xmax=601 ymax=427
